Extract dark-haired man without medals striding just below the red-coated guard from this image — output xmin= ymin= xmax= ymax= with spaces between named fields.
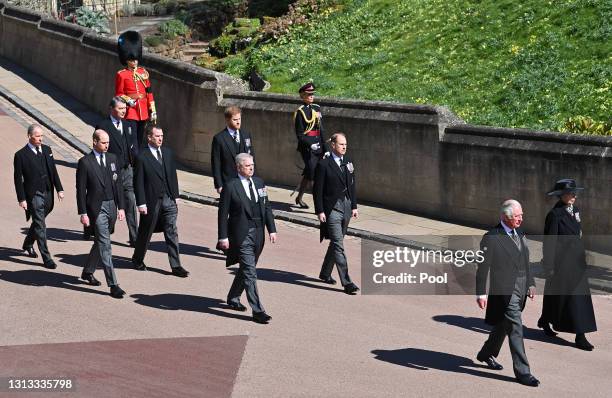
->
xmin=132 ymin=125 xmax=189 ymax=278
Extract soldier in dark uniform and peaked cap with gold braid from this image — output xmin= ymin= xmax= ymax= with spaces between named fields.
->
xmin=293 ymin=83 xmax=327 ymax=209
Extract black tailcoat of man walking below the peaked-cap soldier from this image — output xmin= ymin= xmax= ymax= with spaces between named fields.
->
xmin=312 ymin=155 xmax=357 ymax=240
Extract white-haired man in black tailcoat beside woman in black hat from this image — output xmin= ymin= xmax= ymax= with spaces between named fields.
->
xmin=476 ymin=199 xmax=540 ymax=387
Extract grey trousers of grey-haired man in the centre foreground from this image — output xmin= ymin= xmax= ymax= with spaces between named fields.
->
xmin=227 ymin=227 xmax=265 ymax=312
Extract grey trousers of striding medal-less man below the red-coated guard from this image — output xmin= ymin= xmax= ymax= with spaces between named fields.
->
xmin=132 ymin=195 xmax=181 ymax=268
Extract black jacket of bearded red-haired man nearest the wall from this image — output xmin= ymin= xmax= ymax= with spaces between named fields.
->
xmin=210 ymin=128 xmax=255 ymax=189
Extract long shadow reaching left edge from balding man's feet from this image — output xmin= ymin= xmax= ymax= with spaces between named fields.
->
xmin=0 ymin=270 xmax=108 ymax=296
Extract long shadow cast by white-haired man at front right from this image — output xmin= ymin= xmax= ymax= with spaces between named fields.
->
xmin=372 ymin=348 xmax=516 ymax=383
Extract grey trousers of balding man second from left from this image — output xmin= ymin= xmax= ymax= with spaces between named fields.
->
xmin=83 ymin=200 xmax=117 ymax=286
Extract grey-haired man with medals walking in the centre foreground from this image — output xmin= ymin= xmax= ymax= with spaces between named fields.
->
xmin=217 ymin=153 xmax=276 ymax=324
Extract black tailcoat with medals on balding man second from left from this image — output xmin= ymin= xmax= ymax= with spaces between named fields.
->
xmin=76 ymin=151 xmax=125 ymax=235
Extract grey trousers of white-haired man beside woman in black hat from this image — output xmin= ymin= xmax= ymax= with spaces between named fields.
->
xmin=480 ymin=276 xmax=531 ymax=377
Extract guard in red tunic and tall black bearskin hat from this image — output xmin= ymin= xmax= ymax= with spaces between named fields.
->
xmin=115 ymin=30 xmax=157 ymax=145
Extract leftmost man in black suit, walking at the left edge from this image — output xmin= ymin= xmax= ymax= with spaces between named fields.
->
xmin=13 ymin=124 xmax=64 ymax=269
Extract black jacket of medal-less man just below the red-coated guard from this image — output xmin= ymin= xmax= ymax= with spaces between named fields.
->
xmin=134 ymin=146 xmax=179 ymax=211
